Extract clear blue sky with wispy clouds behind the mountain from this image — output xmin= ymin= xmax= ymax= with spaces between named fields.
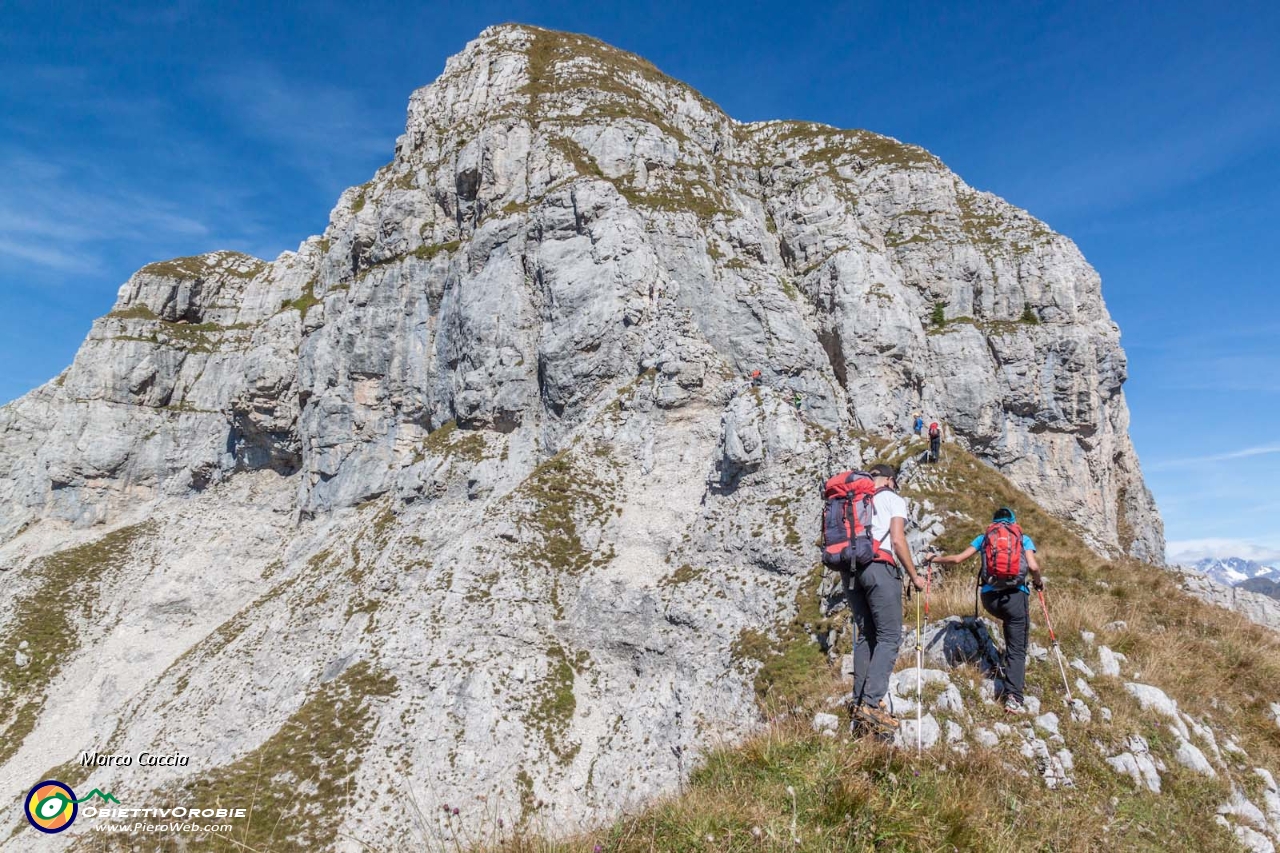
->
xmin=0 ymin=0 xmax=1280 ymax=560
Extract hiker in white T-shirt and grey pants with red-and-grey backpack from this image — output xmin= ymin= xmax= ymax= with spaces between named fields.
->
xmin=823 ymin=462 xmax=924 ymax=736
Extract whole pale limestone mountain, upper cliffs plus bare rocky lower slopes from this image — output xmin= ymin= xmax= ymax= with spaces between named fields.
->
xmin=0 ymin=26 xmax=1164 ymax=843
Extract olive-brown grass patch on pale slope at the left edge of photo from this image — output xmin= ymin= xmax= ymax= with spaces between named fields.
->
xmin=0 ymin=524 xmax=154 ymax=763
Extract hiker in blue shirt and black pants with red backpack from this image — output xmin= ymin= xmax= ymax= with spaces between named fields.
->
xmin=929 ymin=506 xmax=1044 ymax=713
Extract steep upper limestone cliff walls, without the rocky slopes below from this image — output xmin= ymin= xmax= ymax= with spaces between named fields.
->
xmin=0 ymin=27 xmax=1162 ymax=561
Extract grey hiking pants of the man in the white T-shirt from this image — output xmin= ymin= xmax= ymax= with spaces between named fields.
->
xmin=849 ymin=562 xmax=902 ymax=707
